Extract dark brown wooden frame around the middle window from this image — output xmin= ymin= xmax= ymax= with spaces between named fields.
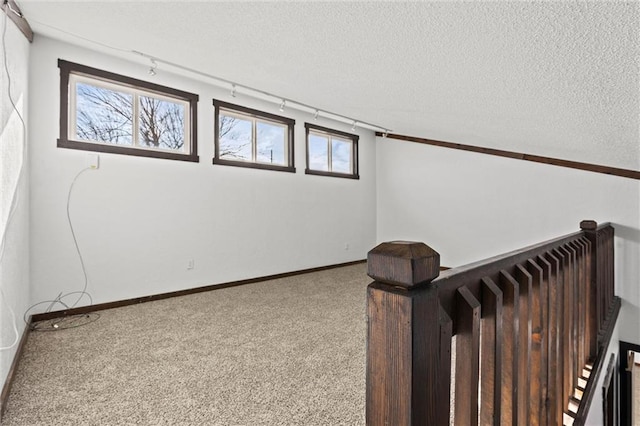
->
xmin=212 ymin=99 xmax=296 ymax=173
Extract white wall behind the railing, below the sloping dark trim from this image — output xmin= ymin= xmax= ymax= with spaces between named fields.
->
xmin=376 ymin=138 xmax=640 ymax=343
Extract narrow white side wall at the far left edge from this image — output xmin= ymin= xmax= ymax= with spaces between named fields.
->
xmin=0 ymin=13 xmax=29 ymax=386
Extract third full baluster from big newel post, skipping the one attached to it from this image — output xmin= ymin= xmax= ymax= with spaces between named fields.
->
xmin=498 ymin=270 xmax=520 ymax=425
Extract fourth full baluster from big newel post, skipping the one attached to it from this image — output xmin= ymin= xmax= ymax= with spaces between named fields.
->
xmin=515 ymin=265 xmax=533 ymax=425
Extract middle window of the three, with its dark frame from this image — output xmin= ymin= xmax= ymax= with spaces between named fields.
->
xmin=213 ymin=99 xmax=296 ymax=172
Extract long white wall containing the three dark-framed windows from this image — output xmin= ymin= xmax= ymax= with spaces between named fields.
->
xmin=30 ymin=37 xmax=376 ymax=303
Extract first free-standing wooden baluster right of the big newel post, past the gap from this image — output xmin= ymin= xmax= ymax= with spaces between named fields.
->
xmin=452 ymin=286 xmax=480 ymax=426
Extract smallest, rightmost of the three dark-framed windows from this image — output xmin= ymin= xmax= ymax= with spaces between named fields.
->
xmin=304 ymin=123 xmax=360 ymax=179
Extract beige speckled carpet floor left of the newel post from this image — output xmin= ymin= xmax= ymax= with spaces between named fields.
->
xmin=3 ymin=264 xmax=371 ymax=426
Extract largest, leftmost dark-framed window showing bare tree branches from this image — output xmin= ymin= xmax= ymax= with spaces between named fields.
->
xmin=58 ymin=60 xmax=198 ymax=162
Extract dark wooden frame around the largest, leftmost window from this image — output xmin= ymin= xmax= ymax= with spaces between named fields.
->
xmin=58 ymin=59 xmax=200 ymax=163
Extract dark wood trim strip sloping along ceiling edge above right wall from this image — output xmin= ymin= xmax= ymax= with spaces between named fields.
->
xmin=376 ymin=132 xmax=640 ymax=180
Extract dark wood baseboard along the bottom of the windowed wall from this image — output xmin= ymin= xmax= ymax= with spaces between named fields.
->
xmin=32 ymin=259 xmax=366 ymax=322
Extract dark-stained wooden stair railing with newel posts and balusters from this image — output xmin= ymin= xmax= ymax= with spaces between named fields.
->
xmin=366 ymin=221 xmax=620 ymax=426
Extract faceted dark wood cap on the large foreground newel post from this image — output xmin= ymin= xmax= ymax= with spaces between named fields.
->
xmin=367 ymin=241 xmax=440 ymax=288
